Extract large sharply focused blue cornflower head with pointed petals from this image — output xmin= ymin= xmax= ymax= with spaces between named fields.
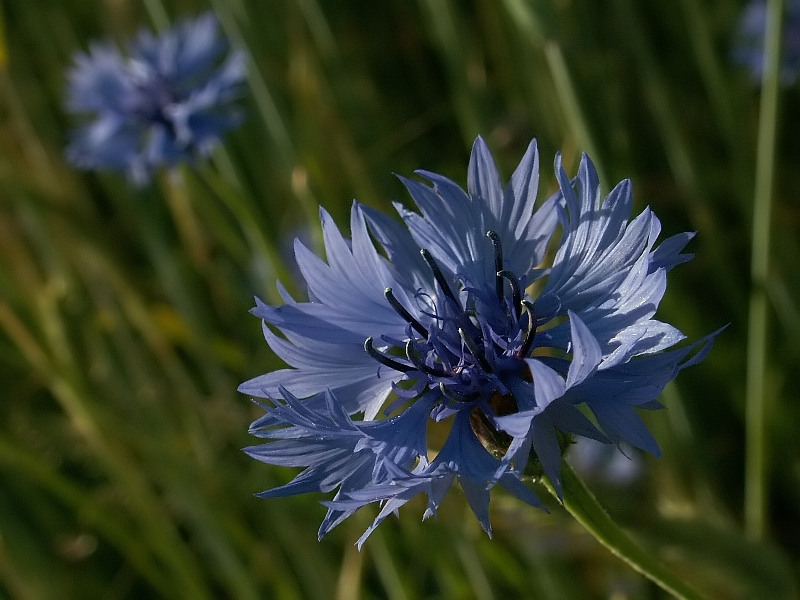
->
xmin=239 ymin=138 xmax=713 ymax=544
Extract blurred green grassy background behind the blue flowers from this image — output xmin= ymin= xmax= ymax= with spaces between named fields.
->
xmin=0 ymin=0 xmax=800 ymax=600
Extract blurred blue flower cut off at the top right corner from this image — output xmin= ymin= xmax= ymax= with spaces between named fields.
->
xmin=732 ymin=0 xmax=800 ymax=85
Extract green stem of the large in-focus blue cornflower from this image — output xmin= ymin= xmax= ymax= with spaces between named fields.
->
xmin=542 ymin=462 xmax=701 ymax=600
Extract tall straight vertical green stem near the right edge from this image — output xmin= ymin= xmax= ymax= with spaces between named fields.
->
xmin=744 ymin=0 xmax=783 ymax=539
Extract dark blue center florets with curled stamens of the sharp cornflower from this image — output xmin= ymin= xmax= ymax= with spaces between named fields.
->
xmin=364 ymin=231 xmax=536 ymax=456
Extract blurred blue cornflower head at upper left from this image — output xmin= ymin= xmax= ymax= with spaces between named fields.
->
xmin=66 ymin=13 xmax=246 ymax=183
